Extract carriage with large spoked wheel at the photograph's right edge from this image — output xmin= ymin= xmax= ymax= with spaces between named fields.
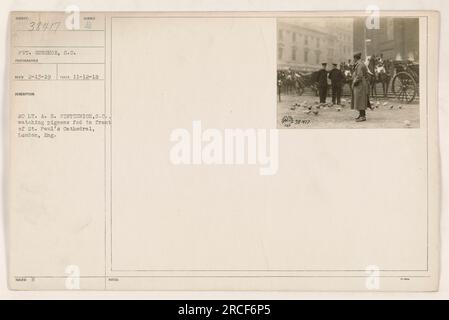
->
xmin=391 ymin=61 xmax=419 ymax=103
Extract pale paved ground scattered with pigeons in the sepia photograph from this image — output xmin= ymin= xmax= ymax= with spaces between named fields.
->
xmin=277 ymin=95 xmax=419 ymax=129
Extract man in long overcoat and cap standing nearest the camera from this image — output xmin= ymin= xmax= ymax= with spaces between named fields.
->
xmin=351 ymin=52 xmax=368 ymax=122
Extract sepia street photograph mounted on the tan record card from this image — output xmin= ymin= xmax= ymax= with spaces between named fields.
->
xmin=277 ymin=17 xmax=422 ymax=129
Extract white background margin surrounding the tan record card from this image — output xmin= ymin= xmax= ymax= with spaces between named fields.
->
xmin=0 ymin=0 xmax=449 ymax=299
